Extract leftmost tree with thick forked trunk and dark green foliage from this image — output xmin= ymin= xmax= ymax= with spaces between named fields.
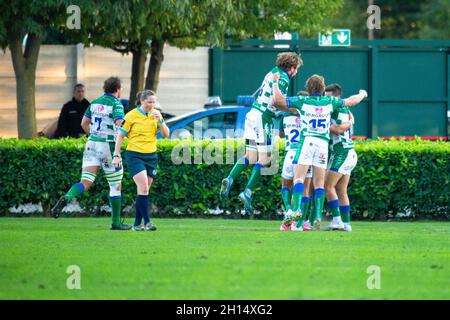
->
xmin=0 ymin=0 xmax=101 ymax=139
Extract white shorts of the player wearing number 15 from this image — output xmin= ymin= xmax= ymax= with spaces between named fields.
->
xmin=297 ymin=136 xmax=328 ymax=169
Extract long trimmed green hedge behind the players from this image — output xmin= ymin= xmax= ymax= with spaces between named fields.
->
xmin=0 ymin=138 xmax=450 ymax=219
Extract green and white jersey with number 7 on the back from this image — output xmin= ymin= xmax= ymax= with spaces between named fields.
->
xmin=84 ymin=93 xmax=125 ymax=142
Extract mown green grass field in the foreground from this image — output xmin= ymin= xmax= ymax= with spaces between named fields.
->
xmin=0 ymin=218 xmax=450 ymax=299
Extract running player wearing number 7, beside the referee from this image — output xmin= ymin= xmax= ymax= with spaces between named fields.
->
xmin=52 ymin=77 xmax=131 ymax=230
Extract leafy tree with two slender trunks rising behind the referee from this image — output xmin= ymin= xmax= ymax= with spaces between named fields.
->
xmin=89 ymin=0 xmax=342 ymax=101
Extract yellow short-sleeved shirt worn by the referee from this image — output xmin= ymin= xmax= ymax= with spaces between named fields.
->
xmin=119 ymin=107 xmax=158 ymax=153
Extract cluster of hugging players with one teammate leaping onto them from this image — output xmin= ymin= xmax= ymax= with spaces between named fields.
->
xmin=220 ymin=52 xmax=367 ymax=231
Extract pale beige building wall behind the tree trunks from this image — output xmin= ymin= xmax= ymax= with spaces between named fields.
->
xmin=0 ymin=45 xmax=208 ymax=137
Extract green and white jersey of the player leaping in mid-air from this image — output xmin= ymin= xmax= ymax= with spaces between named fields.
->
xmin=252 ymin=67 xmax=290 ymax=118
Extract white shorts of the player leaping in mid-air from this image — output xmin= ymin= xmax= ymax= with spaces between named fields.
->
xmin=244 ymin=109 xmax=273 ymax=152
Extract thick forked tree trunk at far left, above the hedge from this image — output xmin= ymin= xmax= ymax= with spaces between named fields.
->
xmin=8 ymin=33 xmax=42 ymax=139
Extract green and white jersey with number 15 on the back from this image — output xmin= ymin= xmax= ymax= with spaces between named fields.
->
xmin=286 ymin=95 xmax=344 ymax=141
